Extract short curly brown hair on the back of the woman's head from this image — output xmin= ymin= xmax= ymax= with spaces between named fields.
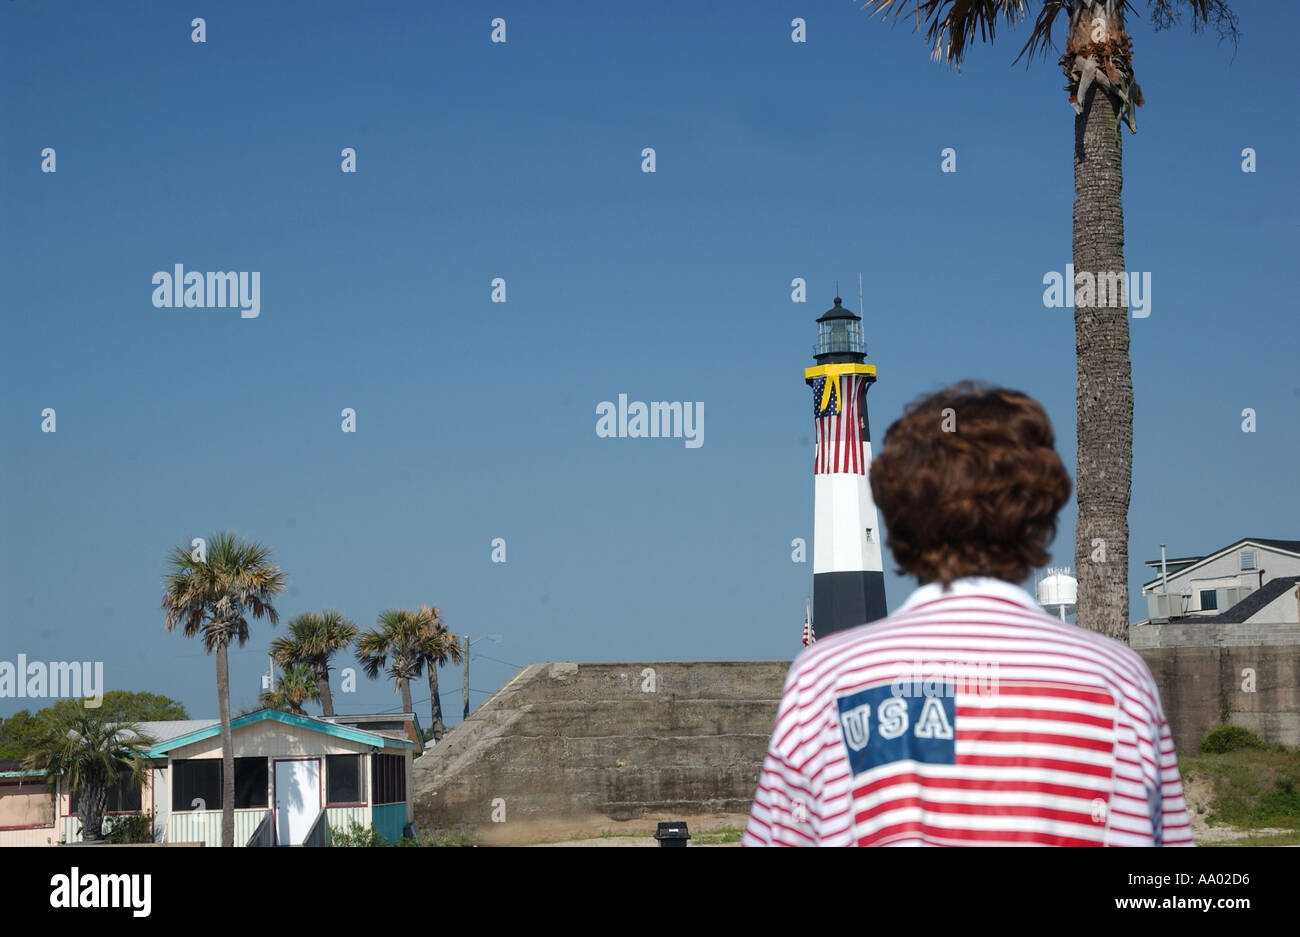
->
xmin=871 ymin=381 xmax=1073 ymax=587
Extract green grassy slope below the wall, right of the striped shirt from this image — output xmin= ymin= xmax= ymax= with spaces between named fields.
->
xmin=1179 ymin=746 xmax=1300 ymax=831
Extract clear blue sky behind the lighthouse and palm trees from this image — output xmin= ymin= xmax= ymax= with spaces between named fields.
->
xmin=0 ymin=0 xmax=1300 ymax=723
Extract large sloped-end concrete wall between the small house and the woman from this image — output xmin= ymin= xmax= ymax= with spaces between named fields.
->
xmin=412 ymin=661 xmax=790 ymax=841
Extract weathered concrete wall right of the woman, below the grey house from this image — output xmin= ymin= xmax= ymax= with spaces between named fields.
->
xmin=1131 ymin=644 xmax=1300 ymax=754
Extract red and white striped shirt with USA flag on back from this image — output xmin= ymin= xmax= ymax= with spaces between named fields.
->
xmin=742 ymin=578 xmax=1192 ymax=846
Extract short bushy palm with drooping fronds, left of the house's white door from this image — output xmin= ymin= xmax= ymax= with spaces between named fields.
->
xmin=23 ymin=707 xmax=153 ymax=842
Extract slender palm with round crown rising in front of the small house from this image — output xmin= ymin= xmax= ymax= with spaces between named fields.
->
xmin=163 ymin=532 xmax=285 ymax=846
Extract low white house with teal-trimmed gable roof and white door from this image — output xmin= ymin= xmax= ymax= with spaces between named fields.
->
xmin=0 ymin=710 xmax=423 ymax=846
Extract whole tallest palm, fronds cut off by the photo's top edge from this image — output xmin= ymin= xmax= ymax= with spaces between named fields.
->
xmin=866 ymin=0 xmax=1236 ymax=641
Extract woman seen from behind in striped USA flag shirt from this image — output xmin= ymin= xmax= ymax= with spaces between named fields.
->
xmin=744 ymin=382 xmax=1192 ymax=846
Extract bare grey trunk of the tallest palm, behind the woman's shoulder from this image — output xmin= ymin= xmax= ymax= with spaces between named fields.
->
xmin=1074 ymin=78 xmax=1134 ymax=642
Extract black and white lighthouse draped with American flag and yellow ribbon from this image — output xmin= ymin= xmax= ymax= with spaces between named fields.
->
xmin=803 ymin=296 xmax=887 ymax=637
